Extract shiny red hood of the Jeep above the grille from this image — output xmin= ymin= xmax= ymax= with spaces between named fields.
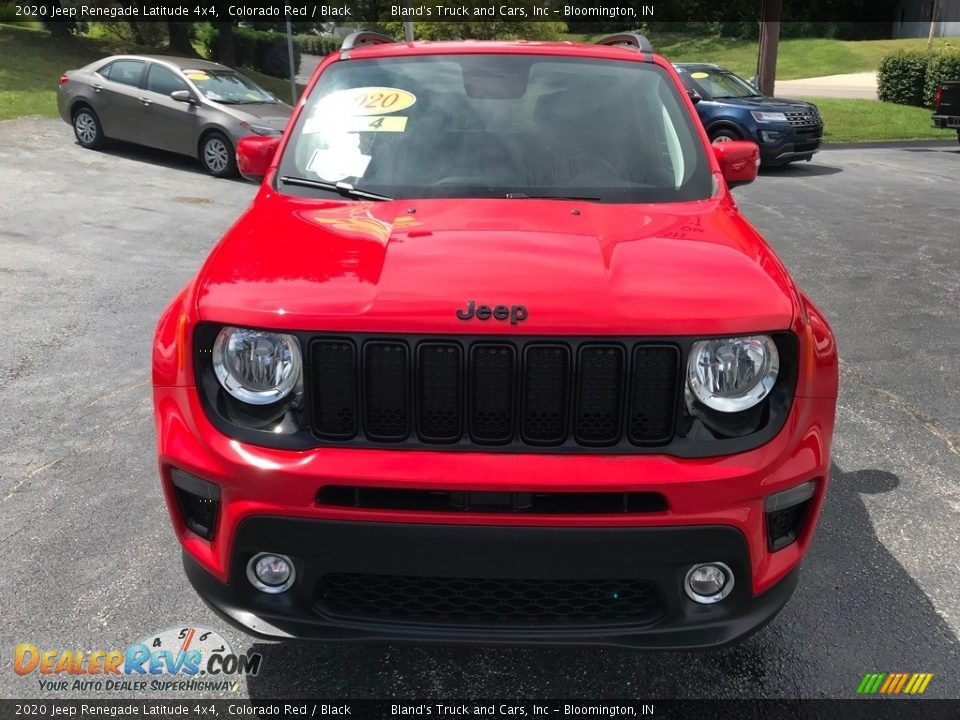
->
xmin=196 ymin=192 xmax=796 ymax=335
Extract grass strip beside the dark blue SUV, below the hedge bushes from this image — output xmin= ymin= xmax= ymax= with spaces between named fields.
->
xmin=804 ymin=98 xmax=956 ymax=142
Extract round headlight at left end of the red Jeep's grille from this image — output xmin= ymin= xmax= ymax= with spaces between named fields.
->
xmin=213 ymin=327 xmax=303 ymax=405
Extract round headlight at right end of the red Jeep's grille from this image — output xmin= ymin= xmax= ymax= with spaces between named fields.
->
xmin=687 ymin=335 xmax=780 ymax=412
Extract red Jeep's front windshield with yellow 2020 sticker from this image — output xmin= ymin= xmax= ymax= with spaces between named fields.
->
xmin=279 ymin=54 xmax=712 ymax=202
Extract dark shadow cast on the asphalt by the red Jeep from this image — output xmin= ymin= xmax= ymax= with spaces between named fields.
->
xmin=247 ymin=466 xmax=960 ymax=699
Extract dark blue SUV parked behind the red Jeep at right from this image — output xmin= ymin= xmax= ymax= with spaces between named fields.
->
xmin=674 ymin=63 xmax=823 ymax=166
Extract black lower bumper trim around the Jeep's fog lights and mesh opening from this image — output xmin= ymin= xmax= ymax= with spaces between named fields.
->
xmin=183 ymin=516 xmax=798 ymax=649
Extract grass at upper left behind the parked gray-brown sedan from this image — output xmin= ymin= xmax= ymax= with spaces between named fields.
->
xmin=0 ymin=25 xmax=302 ymax=120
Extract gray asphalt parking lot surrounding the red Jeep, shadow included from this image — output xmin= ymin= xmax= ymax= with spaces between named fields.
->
xmin=0 ymin=119 xmax=960 ymax=699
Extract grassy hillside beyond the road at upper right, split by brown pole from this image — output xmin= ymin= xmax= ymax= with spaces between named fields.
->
xmin=565 ymin=31 xmax=960 ymax=80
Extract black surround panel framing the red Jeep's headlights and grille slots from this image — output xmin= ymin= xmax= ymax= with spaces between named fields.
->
xmin=194 ymin=323 xmax=799 ymax=458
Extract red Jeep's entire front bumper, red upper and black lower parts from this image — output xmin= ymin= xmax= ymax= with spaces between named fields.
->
xmin=154 ymin=387 xmax=834 ymax=648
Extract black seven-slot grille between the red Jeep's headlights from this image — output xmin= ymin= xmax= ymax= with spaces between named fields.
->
xmin=308 ymin=336 xmax=681 ymax=449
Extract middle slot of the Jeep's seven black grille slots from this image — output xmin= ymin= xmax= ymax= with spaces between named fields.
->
xmin=470 ymin=343 xmax=516 ymax=444
